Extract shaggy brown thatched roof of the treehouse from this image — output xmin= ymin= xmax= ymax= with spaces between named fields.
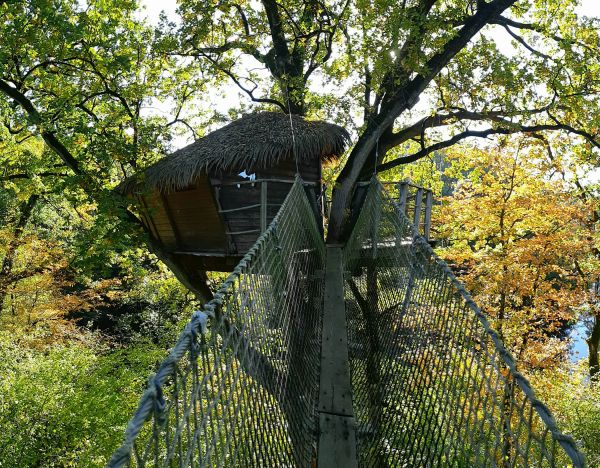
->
xmin=117 ymin=112 xmax=350 ymax=193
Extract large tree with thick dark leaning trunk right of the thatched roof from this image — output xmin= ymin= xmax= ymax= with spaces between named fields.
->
xmin=171 ymin=0 xmax=599 ymax=240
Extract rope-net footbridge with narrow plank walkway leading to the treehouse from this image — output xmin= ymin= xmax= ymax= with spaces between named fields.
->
xmin=109 ymin=178 xmax=584 ymax=467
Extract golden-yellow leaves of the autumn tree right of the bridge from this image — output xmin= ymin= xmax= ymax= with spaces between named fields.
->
xmin=436 ymin=147 xmax=599 ymax=367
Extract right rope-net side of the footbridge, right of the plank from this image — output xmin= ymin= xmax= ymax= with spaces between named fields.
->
xmin=344 ymin=181 xmax=584 ymax=467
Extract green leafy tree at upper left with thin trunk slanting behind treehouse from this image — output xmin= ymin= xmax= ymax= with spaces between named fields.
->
xmin=0 ymin=0 xmax=213 ymax=295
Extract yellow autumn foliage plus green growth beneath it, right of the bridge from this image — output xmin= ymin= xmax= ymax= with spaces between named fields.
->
xmin=435 ymin=142 xmax=600 ymax=466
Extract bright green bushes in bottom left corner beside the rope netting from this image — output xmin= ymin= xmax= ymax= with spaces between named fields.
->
xmin=0 ymin=335 xmax=165 ymax=467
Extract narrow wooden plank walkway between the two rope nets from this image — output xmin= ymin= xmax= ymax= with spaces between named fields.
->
xmin=317 ymin=246 xmax=358 ymax=468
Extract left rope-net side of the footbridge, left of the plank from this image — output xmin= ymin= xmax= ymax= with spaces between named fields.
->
xmin=109 ymin=179 xmax=325 ymax=467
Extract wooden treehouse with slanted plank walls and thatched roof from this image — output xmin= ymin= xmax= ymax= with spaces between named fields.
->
xmin=117 ymin=112 xmax=349 ymax=298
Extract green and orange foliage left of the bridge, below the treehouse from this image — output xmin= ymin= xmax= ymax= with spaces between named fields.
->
xmin=0 ymin=185 xmax=193 ymax=467
